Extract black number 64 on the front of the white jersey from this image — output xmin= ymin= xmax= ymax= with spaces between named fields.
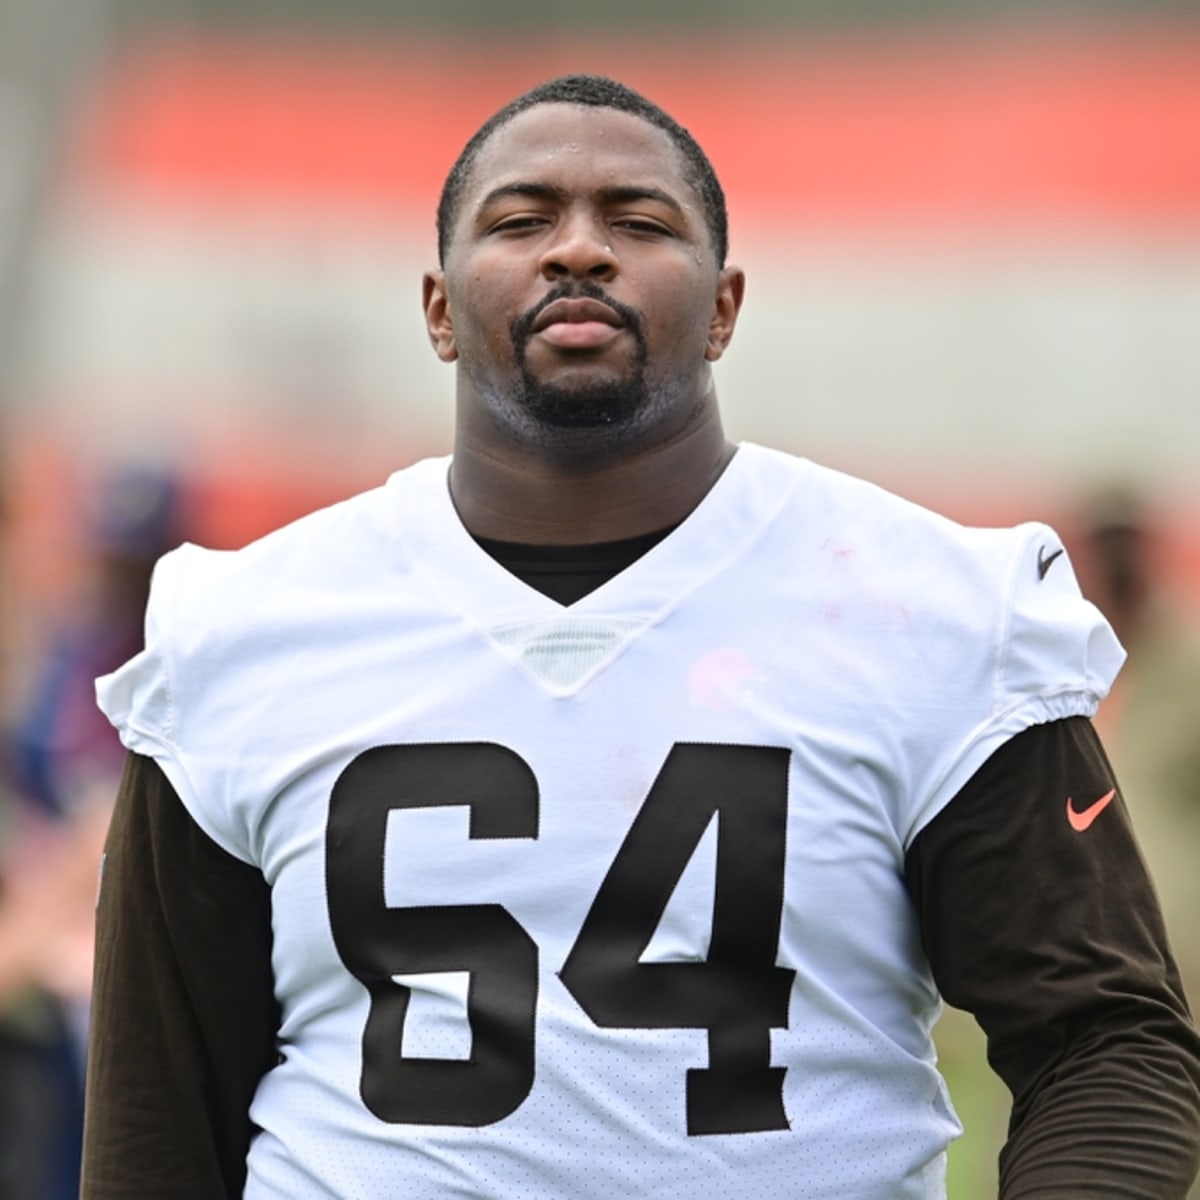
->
xmin=325 ymin=743 xmax=794 ymax=1134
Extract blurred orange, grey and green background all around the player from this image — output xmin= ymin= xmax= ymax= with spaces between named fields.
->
xmin=0 ymin=0 xmax=1200 ymax=1200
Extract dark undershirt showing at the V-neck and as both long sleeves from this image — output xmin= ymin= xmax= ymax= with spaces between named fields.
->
xmin=80 ymin=532 xmax=1200 ymax=1200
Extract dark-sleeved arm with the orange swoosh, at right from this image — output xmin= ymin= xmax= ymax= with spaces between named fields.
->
xmin=906 ymin=718 xmax=1200 ymax=1200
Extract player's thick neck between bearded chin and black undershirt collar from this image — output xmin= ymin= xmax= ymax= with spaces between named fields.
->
xmin=450 ymin=398 xmax=734 ymax=546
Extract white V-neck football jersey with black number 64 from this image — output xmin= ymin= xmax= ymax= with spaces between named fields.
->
xmin=100 ymin=445 xmax=1122 ymax=1200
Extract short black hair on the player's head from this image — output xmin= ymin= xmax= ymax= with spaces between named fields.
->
xmin=438 ymin=74 xmax=730 ymax=266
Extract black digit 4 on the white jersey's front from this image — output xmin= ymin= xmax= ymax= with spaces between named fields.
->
xmin=562 ymin=744 xmax=796 ymax=1134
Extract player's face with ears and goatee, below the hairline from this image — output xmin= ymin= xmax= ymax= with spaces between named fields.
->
xmin=425 ymin=104 xmax=740 ymax=453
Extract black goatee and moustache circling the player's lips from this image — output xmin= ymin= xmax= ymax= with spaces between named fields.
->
xmin=509 ymin=280 xmax=650 ymax=430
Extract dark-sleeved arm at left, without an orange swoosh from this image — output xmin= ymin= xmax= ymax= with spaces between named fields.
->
xmin=80 ymin=755 xmax=278 ymax=1200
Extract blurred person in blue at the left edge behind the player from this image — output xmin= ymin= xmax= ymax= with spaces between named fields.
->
xmin=0 ymin=467 xmax=179 ymax=1200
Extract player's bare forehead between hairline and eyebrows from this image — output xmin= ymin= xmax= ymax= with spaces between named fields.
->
xmin=462 ymin=103 xmax=700 ymax=215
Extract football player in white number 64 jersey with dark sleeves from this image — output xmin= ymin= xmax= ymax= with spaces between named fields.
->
xmin=83 ymin=77 xmax=1200 ymax=1200
